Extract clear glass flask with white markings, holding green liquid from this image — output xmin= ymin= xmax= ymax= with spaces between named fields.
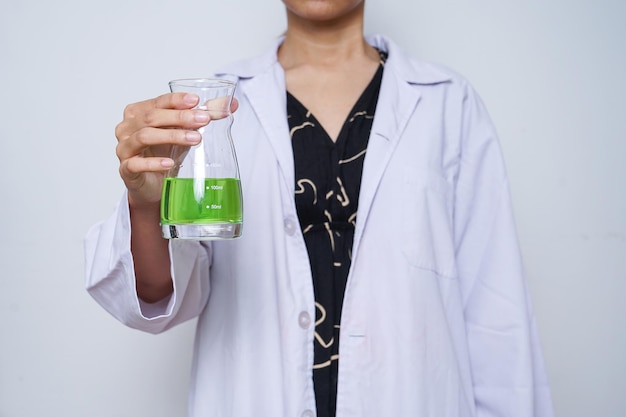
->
xmin=161 ymin=78 xmax=243 ymax=240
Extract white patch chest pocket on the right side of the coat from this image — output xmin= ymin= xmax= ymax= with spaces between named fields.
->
xmin=402 ymin=171 xmax=457 ymax=278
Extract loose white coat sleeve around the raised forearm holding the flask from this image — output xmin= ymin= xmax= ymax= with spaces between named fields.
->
xmin=85 ymin=195 xmax=211 ymax=333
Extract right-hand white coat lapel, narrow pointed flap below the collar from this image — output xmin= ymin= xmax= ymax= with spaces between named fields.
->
xmin=352 ymin=63 xmax=420 ymax=258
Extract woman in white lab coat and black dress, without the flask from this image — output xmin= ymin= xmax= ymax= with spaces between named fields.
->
xmin=86 ymin=0 xmax=552 ymax=417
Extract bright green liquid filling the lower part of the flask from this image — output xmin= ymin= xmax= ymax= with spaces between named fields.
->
xmin=161 ymin=178 xmax=243 ymax=224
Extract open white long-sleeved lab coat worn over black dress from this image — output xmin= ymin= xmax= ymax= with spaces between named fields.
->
xmin=86 ymin=37 xmax=552 ymax=417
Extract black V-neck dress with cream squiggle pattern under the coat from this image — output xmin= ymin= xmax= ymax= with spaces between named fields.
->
xmin=287 ymin=52 xmax=386 ymax=417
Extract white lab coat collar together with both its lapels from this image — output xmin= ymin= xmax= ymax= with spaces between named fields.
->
xmin=218 ymin=36 xmax=453 ymax=259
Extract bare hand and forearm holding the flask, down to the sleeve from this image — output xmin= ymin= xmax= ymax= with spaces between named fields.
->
xmin=115 ymin=93 xmax=238 ymax=302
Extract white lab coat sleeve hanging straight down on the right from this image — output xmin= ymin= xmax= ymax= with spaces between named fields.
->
xmin=454 ymin=86 xmax=553 ymax=417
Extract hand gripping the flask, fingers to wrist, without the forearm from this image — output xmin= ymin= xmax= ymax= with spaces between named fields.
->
xmin=115 ymin=93 xmax=238 ymax=208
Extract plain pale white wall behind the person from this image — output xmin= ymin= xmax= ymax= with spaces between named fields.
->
xmin=0 ymin=0 xmax=626 ymax=417
